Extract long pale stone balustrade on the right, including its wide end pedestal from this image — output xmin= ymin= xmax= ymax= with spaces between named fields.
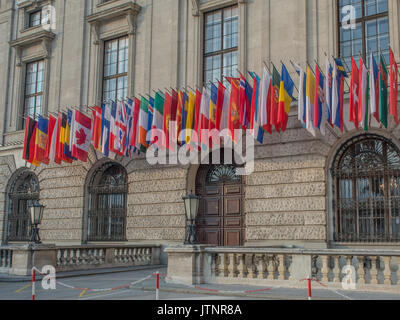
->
xmin=165 ymin=246 xmax=400 ymax=292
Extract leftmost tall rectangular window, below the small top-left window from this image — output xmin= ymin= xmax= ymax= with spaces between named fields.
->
xmin=23 ymin=60 xmax=44 ymax=126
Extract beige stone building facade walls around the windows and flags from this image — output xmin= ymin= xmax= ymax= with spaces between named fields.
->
xmin=0 ymin=0 xmax=400 ymax=255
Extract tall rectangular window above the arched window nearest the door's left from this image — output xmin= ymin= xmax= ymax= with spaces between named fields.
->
xmin=103 ymin=37 xmax=129 ymax=101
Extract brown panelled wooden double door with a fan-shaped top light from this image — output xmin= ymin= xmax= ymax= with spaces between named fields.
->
xmin=196 ymin=164 xmax=245 ymax=246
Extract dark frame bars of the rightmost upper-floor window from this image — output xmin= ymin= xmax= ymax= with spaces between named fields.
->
xmin=336 ymin=0 xmax=390 ymax=67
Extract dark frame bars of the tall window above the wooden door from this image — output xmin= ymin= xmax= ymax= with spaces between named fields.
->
xmin=202 ymin=4 xmax=239 ymax=87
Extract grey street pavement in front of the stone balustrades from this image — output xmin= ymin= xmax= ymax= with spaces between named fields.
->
xmin=0 ymin=267 xmax=400 ymax=301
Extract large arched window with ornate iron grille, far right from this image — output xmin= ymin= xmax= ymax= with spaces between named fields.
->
xmin=332 ymin=135 xmax=400 ymax=242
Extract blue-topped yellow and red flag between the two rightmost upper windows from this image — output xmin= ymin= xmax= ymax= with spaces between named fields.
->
xmin=278 ymin=64 xmax=294 ymax=131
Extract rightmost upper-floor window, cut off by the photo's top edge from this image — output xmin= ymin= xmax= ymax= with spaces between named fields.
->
xmin=338 ymin=0 xmax=389 ymax=68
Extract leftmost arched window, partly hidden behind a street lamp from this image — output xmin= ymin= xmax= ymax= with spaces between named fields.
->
xmin=7 ymin=171 xmax=39 ymax=241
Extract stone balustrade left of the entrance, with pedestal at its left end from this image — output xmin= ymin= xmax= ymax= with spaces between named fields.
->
xmin=0 ymin=244 xmax=161 ymax=276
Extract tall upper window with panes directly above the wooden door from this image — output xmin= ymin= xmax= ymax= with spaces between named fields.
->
xmin=204 ymin=6 xmax=239 ymax=86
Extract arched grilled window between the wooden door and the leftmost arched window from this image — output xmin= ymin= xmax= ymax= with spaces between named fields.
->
xmin=87 ymin=163 xmax=128 ymax=241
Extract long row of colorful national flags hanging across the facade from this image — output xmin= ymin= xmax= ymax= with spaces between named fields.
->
xmin=23 ymin=50 xmax=398 ymax=166
